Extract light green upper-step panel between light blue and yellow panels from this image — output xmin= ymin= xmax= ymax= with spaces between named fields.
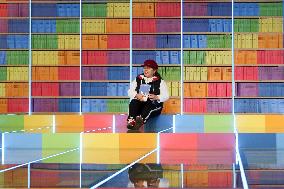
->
xmin=204 ymin=115 xmax=234 ymax=133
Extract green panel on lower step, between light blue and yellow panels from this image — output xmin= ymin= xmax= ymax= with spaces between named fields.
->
xmin=42 ymin=133 xmax=80 ymax=163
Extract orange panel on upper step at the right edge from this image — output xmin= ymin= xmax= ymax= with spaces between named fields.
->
xmin=265 ymin=115 xmax=284 ymax=133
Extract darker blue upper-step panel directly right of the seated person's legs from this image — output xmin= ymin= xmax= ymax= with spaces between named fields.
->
xmin=144 ymin=115 xmax=173 ymax=133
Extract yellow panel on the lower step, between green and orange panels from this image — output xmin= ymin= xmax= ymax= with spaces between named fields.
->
xmin=82 ymin=133 xmax=119 ymax=164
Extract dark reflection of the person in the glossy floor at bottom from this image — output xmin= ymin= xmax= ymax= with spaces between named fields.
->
xmin=128 ymin=163 xmax=168 ymax=188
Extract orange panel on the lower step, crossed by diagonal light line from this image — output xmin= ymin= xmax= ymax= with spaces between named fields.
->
xmin=119 ymin=133 xmax=157 ymax=163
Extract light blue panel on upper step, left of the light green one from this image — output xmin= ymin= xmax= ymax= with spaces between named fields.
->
xmin=176 ymin=115 xmax=204 ymax=133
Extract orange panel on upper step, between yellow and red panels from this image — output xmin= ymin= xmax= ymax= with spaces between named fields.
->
xmin=55 ymin=115 xmax=84 ymax=133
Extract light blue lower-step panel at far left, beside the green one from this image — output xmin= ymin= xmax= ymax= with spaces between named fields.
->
xmin=4 ymin=133 xmax=42 ymax=164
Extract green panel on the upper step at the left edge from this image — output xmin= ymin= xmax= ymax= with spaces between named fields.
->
xmin=0 ymin=115 xmax=24 ymax=132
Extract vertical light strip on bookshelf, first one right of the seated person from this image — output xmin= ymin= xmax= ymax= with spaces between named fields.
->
xmin=180 ymin=0 xmax=184 ymax=115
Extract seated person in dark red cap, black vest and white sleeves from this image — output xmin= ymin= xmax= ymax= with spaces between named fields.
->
xmin=127 ymin=60 xmax=169 ymax=129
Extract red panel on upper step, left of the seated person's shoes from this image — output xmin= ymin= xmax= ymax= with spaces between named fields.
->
xmin=84 ymin=114 xmax=113 ymax=133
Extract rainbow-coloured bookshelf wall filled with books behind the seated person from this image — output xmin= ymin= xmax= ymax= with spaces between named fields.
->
xmin=0 ymin=0 xmax=284 ymax=114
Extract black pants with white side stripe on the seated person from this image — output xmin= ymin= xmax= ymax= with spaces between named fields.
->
xmin=128 ymin=99 xmax=163 ymax=123
